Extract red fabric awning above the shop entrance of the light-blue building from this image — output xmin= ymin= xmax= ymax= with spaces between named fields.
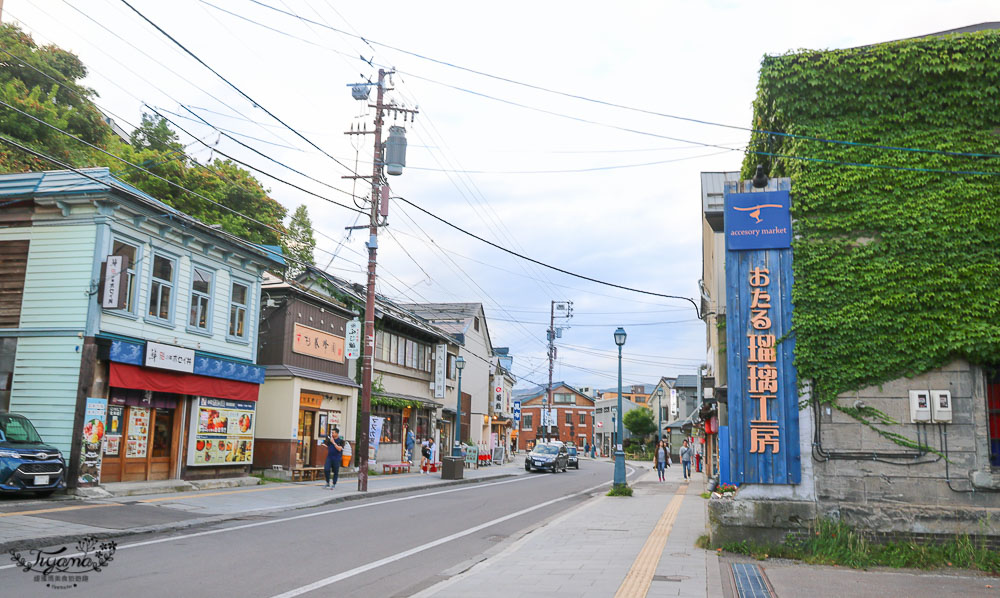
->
xmin=111 ymin=361 xmax=260 ymax=401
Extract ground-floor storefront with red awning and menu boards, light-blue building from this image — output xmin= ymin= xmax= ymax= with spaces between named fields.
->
xmin=97 ymin=340 xmax=263 ymax=483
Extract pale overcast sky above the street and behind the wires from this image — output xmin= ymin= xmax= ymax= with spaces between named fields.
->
xmin=9 ymin=0 xmax=1000 ymax=388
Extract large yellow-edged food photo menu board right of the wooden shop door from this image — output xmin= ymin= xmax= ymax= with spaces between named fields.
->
xmin=187 ymin=397 xmax=257 ymax=465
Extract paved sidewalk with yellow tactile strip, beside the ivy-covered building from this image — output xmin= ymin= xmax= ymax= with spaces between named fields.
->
xmin=417 ymin=463 xmax=722 ymax=598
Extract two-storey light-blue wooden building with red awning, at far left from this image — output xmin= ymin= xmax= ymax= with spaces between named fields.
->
xmin=0 ymin=168 xmax=283 ymax=486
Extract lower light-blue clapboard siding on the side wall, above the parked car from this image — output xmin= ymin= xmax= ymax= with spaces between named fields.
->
xmin=10 ymin=336 xmax=83 ymax=457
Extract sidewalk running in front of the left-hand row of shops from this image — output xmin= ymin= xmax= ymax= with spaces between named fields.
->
xmin=0 ymin=459 xmax=525 ymax=552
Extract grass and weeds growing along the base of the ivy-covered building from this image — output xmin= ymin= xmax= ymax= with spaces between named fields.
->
xmin=722 ymin=520 xmax=1000 ymax=575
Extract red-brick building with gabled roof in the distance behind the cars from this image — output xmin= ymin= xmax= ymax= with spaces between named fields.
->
xmin=517 ymin=382 xmax=594 ymax=450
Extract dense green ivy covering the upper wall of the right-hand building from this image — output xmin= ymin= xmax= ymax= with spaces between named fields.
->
xmin=742 ymin=31 xmax=1000 ymax=436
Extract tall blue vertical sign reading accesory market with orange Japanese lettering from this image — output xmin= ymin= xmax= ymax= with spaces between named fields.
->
xmin=725 ymin=184 xmax=802 ymax=484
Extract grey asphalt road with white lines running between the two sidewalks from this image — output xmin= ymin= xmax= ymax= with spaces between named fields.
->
xmin=0 ymin=462 xmax=628 ymax=598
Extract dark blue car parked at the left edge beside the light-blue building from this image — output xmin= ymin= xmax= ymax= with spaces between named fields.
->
xmin=0 ymin=412 xmax=66 ymax=496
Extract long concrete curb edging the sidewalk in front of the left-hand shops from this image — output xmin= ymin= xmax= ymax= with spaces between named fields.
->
xmin=0 ymin=473 xmax=519 ymax=553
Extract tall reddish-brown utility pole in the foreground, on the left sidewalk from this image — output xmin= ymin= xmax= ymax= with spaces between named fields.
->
xmin=341 ymin=69 xmax=416 ymax=492
